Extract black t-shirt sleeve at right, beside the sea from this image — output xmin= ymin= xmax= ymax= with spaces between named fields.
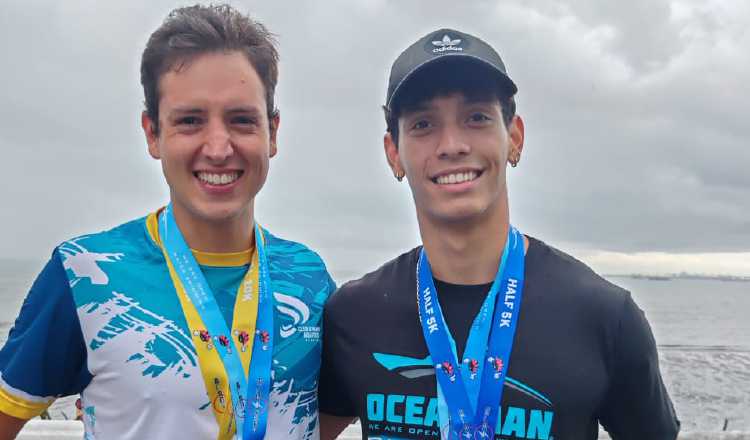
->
xmin=599 ymin=294 xmax=680 ymax=440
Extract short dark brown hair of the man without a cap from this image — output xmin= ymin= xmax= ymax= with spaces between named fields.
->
xmin=141 ymin=5 xmax=279 ymax=133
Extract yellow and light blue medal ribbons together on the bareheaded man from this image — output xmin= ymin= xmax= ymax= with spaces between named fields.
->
xmin=158 ymin=204 xmax=274 ymax=440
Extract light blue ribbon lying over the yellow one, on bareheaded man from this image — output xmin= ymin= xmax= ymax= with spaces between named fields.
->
xmin=159 ymin=203 xmax=274 ymax=440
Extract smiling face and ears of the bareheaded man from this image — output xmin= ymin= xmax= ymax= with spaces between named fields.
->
xmin=142 ymin=52 xmax=279 ymax=224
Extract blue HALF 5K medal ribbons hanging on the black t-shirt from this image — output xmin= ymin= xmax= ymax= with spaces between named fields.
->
xmin=417 ymin=226 xmax=524 ymax=439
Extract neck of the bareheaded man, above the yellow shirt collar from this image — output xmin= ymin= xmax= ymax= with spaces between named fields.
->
xmin=172 ymin=203 xmax=254 ymax=253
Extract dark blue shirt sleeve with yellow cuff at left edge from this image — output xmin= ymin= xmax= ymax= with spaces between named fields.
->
xmin=0 ymin=250 xmax=91 ymax=419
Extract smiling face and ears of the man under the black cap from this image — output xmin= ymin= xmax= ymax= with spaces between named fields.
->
xmin=385 ymin=92 xmax=523 ymax=224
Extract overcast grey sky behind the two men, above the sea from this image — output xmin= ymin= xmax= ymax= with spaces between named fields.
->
xmin=0 ymin=0 xmax=750 ymax=275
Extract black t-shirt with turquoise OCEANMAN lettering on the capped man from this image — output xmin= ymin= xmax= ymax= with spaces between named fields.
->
xmin=319 ymin=238 xmax=679 ymax=440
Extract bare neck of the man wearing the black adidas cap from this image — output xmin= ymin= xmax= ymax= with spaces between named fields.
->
xmin=417 ymin=198 xmax=510 ymax=285
